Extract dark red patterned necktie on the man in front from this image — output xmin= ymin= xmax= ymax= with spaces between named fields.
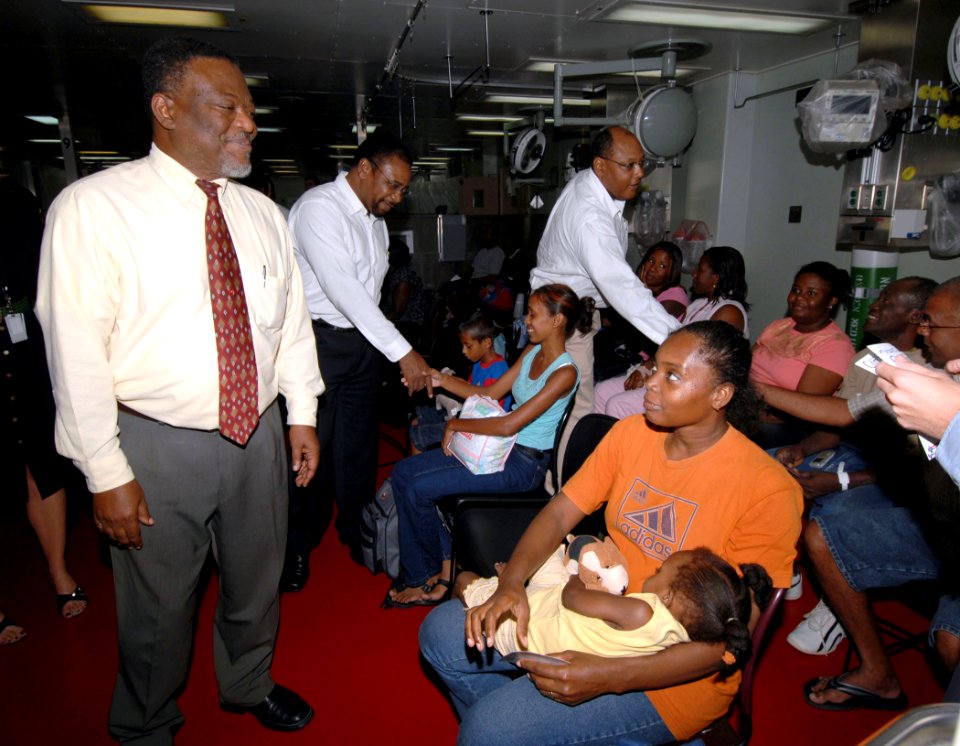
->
xmin=197 ymin=179 xmax=260 ymax=445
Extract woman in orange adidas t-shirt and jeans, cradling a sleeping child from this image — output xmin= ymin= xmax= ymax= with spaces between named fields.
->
xmin=420 ymin=321 xmax=803 ymax=744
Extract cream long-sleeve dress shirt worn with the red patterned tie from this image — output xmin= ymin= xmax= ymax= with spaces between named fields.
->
xmin=36 ymin=145 xmax=323 ymax=492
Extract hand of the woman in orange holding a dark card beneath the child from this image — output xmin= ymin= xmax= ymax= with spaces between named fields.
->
xmin=518 ymin=650 xmax=619 ymax=705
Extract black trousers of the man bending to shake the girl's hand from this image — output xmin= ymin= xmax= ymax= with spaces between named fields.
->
xmin=287 ymin=321 xmax=383 ymax=553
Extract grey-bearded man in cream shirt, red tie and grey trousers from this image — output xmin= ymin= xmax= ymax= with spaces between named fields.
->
xmin=36 ymin=38 xmax=323 ymax=744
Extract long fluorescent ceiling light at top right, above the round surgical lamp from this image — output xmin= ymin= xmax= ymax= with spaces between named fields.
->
xmin=598 ymin=3 xmax=833 ymax=34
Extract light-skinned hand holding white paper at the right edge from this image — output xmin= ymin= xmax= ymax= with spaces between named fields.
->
xmin=877 ymin=360 xmax=960 ymax=440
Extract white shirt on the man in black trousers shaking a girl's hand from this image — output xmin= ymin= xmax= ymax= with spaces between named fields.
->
xmin=289 ymin=173 xmax=412 ymax=362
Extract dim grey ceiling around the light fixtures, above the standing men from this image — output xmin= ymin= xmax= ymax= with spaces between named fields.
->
xmin=0 ymin=0 xmax=859 ymax=170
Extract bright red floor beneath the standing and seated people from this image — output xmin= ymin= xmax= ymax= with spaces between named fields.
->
xmin=0 ymin=428 xmax=942 ymax=746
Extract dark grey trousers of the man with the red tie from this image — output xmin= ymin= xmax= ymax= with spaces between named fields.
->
xmin=109 ymin=403 xmax=288 ymax=744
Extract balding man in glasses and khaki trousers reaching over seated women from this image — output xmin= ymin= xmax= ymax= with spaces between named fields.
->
xmin=530 ymin=127 xmax=680 ymax=476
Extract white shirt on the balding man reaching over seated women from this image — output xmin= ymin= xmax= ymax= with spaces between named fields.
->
xmin=530 ymin=169 xmax=680 ymax=344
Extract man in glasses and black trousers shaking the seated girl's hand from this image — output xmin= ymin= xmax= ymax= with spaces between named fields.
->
xmin=281 ymin=132 xmax=430 ymax=580
